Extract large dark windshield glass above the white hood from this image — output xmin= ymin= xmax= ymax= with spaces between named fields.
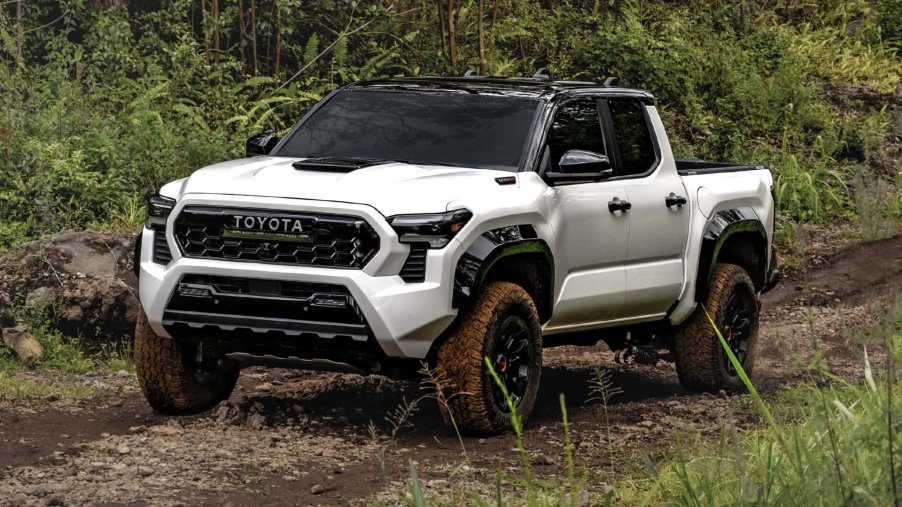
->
xmin=278 ymin=90 xmax=539 ymax=171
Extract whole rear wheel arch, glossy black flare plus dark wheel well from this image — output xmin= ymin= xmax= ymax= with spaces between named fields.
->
xmin=695 ymin=207 xmax=769 ymax=301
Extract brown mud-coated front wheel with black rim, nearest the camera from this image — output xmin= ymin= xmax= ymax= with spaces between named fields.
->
xmin=436 ymin=282 xmax=542 ymax=434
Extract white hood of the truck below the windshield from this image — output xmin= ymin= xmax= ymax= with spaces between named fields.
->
xmin=181 ymin=157 xmax=513 ymax=216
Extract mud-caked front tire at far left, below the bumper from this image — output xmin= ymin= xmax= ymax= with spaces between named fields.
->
xmin=135 ymin=310 xmax=239 ymax=414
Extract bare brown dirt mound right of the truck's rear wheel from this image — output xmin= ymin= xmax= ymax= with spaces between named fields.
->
xmin=764 ymin=236 xmax=902 ymax=306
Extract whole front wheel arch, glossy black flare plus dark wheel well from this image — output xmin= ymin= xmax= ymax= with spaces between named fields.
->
xmin=452 ymin=225 xmax=554 ymax=322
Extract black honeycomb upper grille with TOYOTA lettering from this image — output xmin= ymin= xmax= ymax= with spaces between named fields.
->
xmin=175 ymin=206 xmax=379 ymax=269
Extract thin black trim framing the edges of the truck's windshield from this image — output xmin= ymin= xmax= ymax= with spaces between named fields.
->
xmin=271 ymin=85 xmax=547 ymax=173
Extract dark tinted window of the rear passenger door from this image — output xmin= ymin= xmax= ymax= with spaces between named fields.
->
xmin=609 ymin=99 xmax=657 ymax=176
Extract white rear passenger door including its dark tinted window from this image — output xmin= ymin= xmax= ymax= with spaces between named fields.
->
xmin=602 ymin=98 xmax=690 ymax=317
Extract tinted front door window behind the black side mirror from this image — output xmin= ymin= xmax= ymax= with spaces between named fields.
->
xmin=548 ymin=99 xmax=607 ymax=169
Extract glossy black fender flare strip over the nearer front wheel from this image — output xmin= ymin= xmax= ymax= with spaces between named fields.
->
xmin=452 ymin=225 xmax=554 ymax=317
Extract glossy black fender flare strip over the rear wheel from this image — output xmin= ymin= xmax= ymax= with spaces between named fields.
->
xmin=695 ymin=207 xmax=769 ymax=301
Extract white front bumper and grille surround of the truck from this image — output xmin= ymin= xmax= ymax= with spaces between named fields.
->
xmin=139 ymin=194 xmax=460 ymax=358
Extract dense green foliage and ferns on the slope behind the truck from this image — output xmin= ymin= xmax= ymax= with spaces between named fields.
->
xmin=0 ymin=0 xmax=902 ymax=244
